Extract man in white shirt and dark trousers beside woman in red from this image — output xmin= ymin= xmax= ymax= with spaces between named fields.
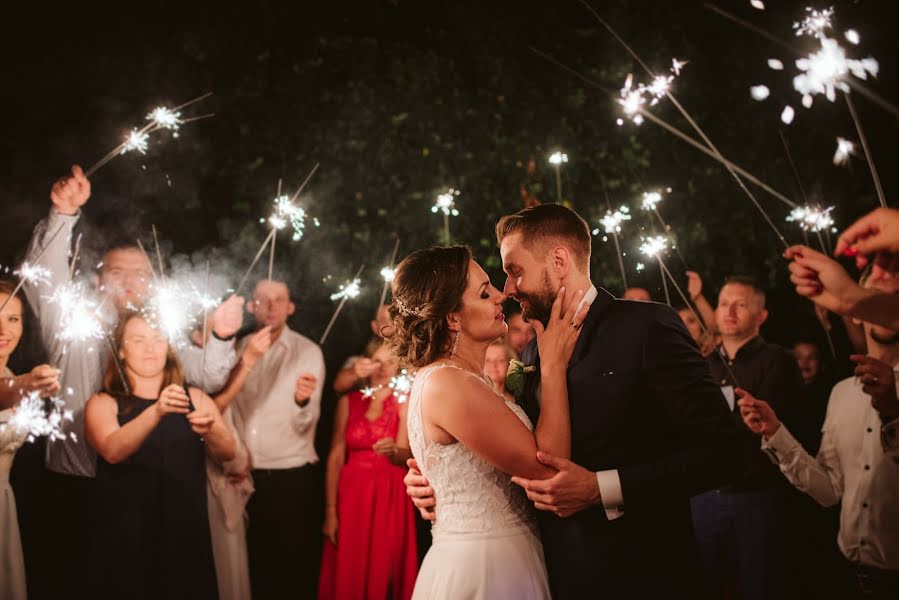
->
xmin=233 ymin=280 xmax=325 ymax=600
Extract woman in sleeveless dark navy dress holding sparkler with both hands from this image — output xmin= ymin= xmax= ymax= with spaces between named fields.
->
xmin=85 ymin=313 xmax=235 ymax=598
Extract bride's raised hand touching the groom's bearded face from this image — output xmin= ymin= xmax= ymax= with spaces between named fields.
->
xmin=532 ymin=287 xmax=590 ymax=369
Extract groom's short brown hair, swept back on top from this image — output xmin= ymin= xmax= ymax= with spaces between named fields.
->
xmin=496 ymin=204 xmax=590 ymax=272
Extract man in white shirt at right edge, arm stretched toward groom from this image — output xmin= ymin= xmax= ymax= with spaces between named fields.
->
xmin=738 ymin=271 xmax=899 ymax=599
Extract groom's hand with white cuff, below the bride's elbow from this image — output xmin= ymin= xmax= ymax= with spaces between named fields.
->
xmin=512 ymin=452 xmax=602 ymax=517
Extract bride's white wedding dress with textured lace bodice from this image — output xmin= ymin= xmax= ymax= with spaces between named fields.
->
xmin=408 ymin=365 xmax=550 ymax=600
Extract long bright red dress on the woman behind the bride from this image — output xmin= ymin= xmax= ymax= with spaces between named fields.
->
xmin=318 ymin=392 xmax=418 ymax=600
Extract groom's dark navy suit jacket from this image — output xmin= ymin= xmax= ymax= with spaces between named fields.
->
xmin=521 ymin=289 xmax=740 ymax=600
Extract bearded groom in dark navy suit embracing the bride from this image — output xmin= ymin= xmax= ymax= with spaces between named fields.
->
xmin=406 ymin=204 xmax=739 ymax=599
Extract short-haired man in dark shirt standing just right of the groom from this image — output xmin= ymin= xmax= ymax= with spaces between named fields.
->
xmin=691 ymin=277 xmax=802 ymax=600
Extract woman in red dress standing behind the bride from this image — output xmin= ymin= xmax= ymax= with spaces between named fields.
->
xmin=318 ymin=346 xmax=418 ymax=600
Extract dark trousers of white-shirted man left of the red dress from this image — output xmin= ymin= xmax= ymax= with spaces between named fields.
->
xmin=247 ymin=465 xmax=323 ymax=600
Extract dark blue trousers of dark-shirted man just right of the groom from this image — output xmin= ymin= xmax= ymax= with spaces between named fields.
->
xmin=691 ymin=490 xmax=776 ymax=600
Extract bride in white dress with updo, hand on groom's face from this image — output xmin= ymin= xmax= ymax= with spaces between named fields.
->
xmin=388 ymin=246 xmax=586 ymax=600
